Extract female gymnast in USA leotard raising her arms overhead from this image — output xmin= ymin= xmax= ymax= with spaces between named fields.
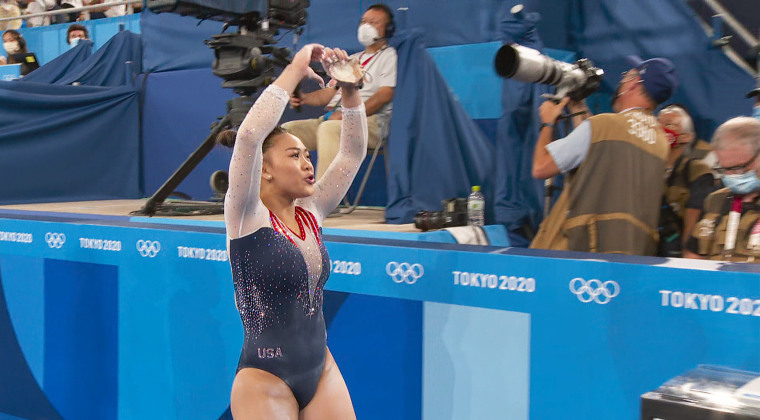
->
xmin=224 ymin=44 xmax=367 ymax=420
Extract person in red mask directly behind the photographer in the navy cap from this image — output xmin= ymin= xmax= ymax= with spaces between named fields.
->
xmin=658 ymin=105 xmax=716 ymax=257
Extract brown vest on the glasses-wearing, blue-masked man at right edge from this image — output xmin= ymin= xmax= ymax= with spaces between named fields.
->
xmin=692 ymin=188 xmax=760 ymax=262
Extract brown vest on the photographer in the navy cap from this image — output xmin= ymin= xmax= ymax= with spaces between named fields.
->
xmin=531 ymin=109 xmax=668 ymax=255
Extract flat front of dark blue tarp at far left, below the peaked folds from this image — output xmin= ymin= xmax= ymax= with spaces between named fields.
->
xmin=0 ymin=82 xmax=140 ymax=204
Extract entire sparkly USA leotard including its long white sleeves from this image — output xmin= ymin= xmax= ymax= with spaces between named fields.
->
xmin=224 ymin=85 xmax=367 ymax=409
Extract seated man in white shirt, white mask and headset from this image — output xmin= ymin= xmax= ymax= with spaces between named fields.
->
xmin=283 ymin=4 xmax=397 ymax=179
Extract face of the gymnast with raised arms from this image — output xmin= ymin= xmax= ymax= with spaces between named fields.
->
xmin=261 ymin=133 xmax=315 ymax=200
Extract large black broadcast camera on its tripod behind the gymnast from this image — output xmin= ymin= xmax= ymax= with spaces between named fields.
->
xmin=133 ymin=0 xmax=309 ymax=216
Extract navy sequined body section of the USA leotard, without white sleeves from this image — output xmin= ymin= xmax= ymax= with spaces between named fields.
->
xmin=230 ymin=228 xmax=330 ymax=409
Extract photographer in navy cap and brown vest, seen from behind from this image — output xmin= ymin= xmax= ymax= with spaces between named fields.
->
xmin=531 ymin=56 xmax=677 ymax=255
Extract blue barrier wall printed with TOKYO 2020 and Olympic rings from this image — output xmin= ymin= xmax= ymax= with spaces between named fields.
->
xmin=0 ymin=213 xmax=760 ymax=420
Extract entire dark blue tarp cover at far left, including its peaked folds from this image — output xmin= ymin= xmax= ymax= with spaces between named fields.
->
xmin=0 ymin=31 xmax=142 ymax=204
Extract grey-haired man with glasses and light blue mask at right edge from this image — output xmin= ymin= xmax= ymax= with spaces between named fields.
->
xmin=684 ymin=117 xmax=760 ymax=262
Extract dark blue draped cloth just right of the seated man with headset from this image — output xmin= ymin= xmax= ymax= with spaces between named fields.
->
xmin=385 ymin=30 xmax=493 ymax=223
